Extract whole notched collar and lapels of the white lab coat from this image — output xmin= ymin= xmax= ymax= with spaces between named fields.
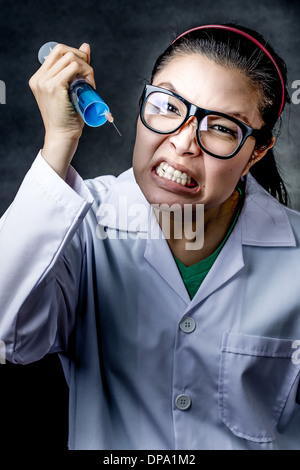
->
xmin=97 ymin=169 xmax=296 ymax=313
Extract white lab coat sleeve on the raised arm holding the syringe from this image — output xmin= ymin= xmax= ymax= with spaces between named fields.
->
xmin=0 ymin=153 xmax=92 ymax=363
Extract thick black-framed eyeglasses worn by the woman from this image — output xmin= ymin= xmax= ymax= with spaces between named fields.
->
xmin=140 ymin=85 xmax=262 ymax=158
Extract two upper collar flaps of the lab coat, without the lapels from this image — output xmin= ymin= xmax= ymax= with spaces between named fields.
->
xmin=97 ymin=168 xmax=296 ymax=246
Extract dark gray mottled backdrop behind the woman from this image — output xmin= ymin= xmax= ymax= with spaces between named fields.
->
xmin=0 ymin=0 xmax=300 ymax=451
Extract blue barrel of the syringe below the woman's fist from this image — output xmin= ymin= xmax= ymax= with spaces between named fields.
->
xmin=69 ymin=78 xmax=110 ymax=127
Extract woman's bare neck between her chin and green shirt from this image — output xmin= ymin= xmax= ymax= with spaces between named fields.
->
xmin=156 ymin=191 xmax=239 ymax=266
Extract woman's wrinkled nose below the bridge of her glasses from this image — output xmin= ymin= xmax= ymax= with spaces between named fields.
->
xmin=169 ymin=116 xmax=201 ymax=157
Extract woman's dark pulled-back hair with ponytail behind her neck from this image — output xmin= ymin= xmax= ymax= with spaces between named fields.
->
xmin=151 ymin=23 xmax=290 ymax=205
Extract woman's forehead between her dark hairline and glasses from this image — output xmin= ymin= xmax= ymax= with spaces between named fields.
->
xmin=153 ymin=54 xmax=262 ymax=126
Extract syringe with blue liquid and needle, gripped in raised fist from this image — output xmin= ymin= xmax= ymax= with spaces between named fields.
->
xmin=38 ymin=41 xmax=121 ymax=136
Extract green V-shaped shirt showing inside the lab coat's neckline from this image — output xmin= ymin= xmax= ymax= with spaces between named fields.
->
xmin=174 ymin=188 xmax=243 ymax=299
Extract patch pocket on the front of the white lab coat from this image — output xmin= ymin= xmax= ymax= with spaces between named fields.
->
xmin=219 ymin=332 xmax=300 ymax=442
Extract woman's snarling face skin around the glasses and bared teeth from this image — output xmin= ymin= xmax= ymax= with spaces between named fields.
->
xmin=133 ymin=54 xmax=263 ymax=209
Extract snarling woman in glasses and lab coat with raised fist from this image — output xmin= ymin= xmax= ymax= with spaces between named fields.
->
xmin=0 ymin=25 xmax=300 ymax=449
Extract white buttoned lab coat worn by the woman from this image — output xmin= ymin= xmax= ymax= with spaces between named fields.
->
xmin=0 ymin=155 xmax=300 ymax=450
